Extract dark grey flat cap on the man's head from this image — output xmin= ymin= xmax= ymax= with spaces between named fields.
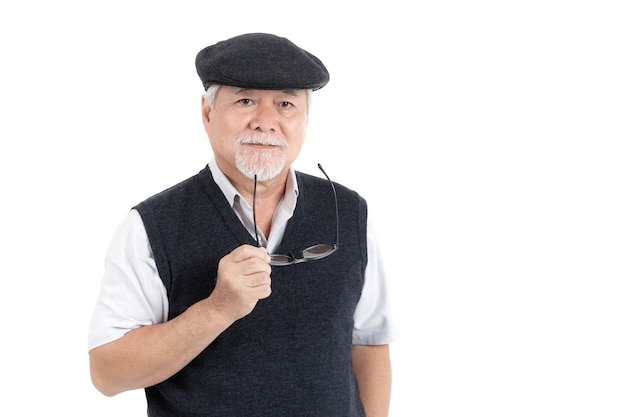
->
xmin=196 ymin=33 xmax=330 ymax=90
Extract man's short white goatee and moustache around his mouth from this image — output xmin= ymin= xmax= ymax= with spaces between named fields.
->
xmin=235 ymin=133 xmax=287 ymax=181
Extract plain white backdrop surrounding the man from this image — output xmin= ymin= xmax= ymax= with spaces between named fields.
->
xmin=0 ymin=0 xmax=626 ymax=417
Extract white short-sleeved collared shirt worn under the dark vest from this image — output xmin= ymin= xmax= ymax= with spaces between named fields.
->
xmin=88 ymin=159 xmax=395 ymax=350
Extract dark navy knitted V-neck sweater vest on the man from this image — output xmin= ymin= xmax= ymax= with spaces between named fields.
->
xmin=135 ymin=166 xmax=367 ymax=417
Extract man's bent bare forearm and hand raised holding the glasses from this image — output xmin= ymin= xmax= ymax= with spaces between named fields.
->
xmin=89 ymin=245 xmax=271 ymax=396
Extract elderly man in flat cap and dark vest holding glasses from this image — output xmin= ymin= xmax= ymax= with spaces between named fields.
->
xmin=89 ymin=33 xmax=394 ymax=417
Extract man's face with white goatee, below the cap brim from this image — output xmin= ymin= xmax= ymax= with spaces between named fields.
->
xmin=202 ymin=86 xmax=308 ymax=181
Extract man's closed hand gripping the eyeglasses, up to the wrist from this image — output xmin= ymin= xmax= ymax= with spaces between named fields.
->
xmin=208 ymin=245 xmax=272 ymax=322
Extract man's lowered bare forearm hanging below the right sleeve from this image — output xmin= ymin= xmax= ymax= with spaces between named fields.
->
xmin=352 ymin=345 xmax=391 ymax=417
